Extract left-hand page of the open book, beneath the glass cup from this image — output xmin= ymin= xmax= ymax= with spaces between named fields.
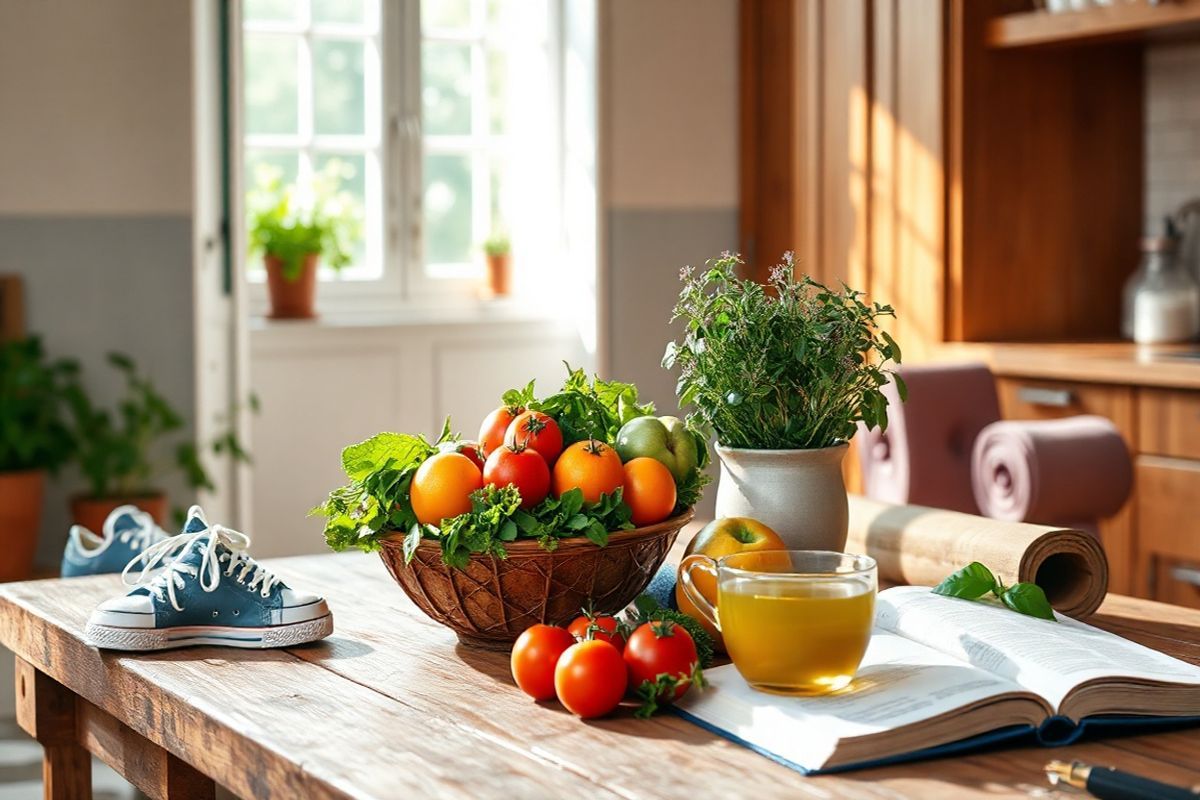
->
xmin=678 ymin=631 xmax=1042 ymax=770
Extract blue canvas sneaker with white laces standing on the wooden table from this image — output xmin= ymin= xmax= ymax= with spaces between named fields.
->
xmin=84 ymin=506 xmax=334 ymax=650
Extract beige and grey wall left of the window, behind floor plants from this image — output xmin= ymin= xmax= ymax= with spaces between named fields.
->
xmin=0 ymin=0 xmax=194 ymax=566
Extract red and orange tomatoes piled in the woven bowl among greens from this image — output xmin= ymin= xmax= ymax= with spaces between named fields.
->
xmin=409 ymin=405 xmax=676 ymax=525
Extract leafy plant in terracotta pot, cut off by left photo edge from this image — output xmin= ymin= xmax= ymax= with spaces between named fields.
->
xmin=0 ymin=337 xmax=79 ymax=581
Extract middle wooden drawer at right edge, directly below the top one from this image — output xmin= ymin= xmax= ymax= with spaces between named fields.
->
xmin=1135 ymin=456 xmax=1200 ymax=563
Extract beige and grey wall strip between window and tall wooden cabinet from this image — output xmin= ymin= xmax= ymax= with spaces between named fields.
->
xmin=600 ymin=0 xmax=738 ymax=516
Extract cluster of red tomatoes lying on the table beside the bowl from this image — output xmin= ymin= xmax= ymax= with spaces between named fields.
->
xmin=511 ymin=614 xmax=700 ymax=720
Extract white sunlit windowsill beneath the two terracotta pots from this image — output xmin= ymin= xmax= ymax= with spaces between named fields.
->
xmin=250 ymin=297 xmax=563 ymax=332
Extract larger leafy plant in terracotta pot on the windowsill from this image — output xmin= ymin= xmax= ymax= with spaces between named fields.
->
xmin=246 ymin=160 xmax=362 ymax=319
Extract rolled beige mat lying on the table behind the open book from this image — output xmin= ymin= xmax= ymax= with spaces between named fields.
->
xmin=846 ymin=495 xmax=1109 ymax=618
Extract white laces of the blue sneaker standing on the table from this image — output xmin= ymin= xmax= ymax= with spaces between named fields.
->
xmin=121 ymin=525 xmax=280 ymax=612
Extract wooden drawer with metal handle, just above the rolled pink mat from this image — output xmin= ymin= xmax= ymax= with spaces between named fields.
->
xmin=996 ymin=378 xmax=1136 ymax=450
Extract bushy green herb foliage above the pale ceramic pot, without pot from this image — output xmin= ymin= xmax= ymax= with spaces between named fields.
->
xmin=662 ymin=253 xmax=906 ymax=449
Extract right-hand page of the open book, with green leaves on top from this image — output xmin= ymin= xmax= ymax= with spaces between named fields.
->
xmin=875 ymin=587 xmax=1200 ymax=710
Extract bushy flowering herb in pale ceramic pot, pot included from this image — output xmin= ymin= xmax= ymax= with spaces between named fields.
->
xmin=662 ymin=253 xmax=905 ymax=551
